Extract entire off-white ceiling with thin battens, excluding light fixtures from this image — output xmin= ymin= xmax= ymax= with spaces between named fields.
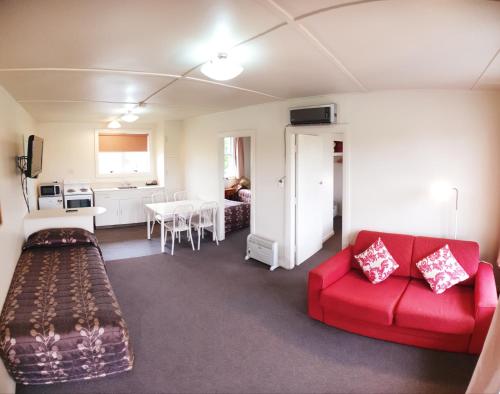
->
xmin=0 ymin=0 xmax=500 ymax=121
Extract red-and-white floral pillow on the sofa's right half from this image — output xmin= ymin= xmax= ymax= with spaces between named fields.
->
xmin=417 ymin=245 xmax=469 ymax=294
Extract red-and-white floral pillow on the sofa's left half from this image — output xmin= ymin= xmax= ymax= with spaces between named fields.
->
xmin=354 ymin=237 xmax=399 ymax=285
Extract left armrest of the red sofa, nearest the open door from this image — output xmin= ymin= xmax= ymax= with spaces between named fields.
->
xmin=307 ymin=246 xmax=352 ymax=321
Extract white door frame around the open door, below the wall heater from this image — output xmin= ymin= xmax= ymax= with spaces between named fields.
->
xmin=285 ymin=124 xmax=351 ymax=268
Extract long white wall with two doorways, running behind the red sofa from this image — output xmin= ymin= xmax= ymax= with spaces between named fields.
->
xmin=184 ymin=90 xmax=500 ymax=266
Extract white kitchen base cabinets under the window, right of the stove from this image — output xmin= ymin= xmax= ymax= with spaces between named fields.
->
xmin=94 ymin=186 xmax=163 ymax=227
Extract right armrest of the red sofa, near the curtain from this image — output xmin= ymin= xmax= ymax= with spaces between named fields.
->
xmin=469 ymin=261 xmax=498 ymax=354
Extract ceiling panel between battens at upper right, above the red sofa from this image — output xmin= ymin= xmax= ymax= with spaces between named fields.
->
xmin=301 ymin=0 xmax=500 ymax=90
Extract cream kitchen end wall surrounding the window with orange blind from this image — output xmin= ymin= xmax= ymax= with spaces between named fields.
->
xmin=38 ymin=122 xmax=164 ymax=184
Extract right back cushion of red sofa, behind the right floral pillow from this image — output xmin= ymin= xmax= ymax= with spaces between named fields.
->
xmin=410 ymin=237 xmax=479 ymax=286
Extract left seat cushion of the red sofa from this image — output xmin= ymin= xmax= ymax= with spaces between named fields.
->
xmin=320 ymin=270 xmax=409 ymax=326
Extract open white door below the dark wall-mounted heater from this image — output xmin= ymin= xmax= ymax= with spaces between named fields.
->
xmin=295 ymin=134 xmax=324 ymax=265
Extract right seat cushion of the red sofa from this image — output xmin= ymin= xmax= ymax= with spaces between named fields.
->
xmin=395 ymin=279 xmax=475 ymax=334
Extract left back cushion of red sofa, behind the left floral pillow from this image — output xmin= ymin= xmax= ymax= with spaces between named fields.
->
xmin=352 ymin=230 xmax=416 ymax=277
